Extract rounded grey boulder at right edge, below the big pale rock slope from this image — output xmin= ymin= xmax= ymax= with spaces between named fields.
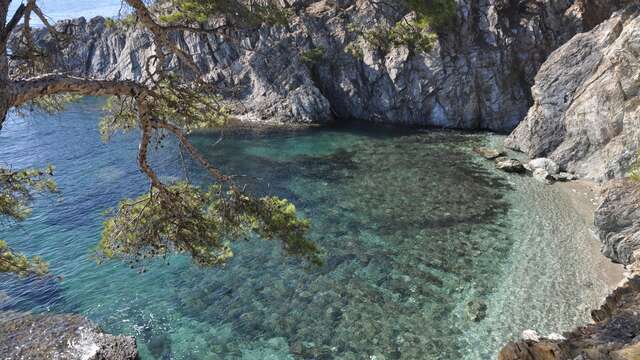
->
xmin=595 ymin=179 xmax=640 ymax=264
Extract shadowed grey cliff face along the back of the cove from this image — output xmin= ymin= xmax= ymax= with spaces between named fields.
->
xmin=31 ymin=0 xmax=617 ymax=130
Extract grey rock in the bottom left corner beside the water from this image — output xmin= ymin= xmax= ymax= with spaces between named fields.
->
xmin=0 ymin=312 xmax=138 ymax=360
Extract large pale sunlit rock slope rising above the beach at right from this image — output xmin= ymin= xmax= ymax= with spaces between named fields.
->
xmin=505 ymin=5 xmax=640 ymax=180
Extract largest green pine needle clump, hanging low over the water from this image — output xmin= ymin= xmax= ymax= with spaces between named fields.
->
xmin=98 ymin=182 xmax=320 ymax=266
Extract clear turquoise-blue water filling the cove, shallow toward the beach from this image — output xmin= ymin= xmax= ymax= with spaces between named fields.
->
xmin=0 ymin=99 xmax=607 ymax=359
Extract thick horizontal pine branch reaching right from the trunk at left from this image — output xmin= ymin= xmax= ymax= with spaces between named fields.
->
xmin=9 ymin=74 xmax=147 ymax=106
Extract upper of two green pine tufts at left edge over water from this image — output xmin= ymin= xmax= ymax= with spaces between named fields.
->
xmin=0 ymin=166 xmax=57 ymax=220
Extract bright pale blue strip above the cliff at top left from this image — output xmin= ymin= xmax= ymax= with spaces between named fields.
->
xmin=10 ymin=0 xmax=121 ymax=25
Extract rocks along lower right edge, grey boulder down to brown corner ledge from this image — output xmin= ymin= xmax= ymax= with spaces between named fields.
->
xmin=499 ymin=179 xmax=640 ymax=360
